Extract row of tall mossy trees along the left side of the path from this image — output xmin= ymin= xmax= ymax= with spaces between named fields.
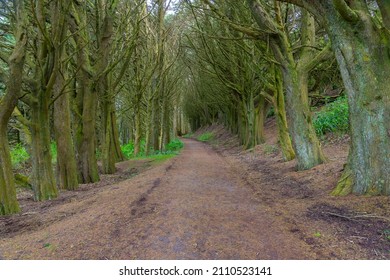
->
xmin=0 ymin=0 xmax=184 ymax=214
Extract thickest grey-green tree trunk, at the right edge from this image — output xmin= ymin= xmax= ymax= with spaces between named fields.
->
xmin=324 ymin=6 xmax=390 ymax=195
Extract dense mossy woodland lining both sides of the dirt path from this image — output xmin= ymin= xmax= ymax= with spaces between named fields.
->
xmin=0 ymin=0 xmax=390 ymax=217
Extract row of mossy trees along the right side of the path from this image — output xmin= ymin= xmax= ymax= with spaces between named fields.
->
xmin=181 ymin=0 xmax=390 ymax=195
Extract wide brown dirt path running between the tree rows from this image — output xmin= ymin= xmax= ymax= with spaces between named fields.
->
xmin=0 ymin=139 xmax=316 ymax=259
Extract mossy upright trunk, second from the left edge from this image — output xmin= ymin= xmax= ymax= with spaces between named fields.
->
xmin=29 ymin=0 xmax=64 ymax=201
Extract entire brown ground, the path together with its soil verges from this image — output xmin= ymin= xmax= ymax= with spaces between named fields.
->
xmin=0 ymin=122 xmax=390 ymax=259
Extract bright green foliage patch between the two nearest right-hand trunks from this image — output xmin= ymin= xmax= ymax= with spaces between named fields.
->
xmin=313 ymin=97 xmax=349 ymax=136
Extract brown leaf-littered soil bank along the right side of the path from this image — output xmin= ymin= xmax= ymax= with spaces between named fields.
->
xmin=194 ymin=119 xmax=390 ymax=259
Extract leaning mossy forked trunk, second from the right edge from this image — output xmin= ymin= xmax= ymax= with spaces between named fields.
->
xmin=248 ymin=0 xmax=327 ymax=170
